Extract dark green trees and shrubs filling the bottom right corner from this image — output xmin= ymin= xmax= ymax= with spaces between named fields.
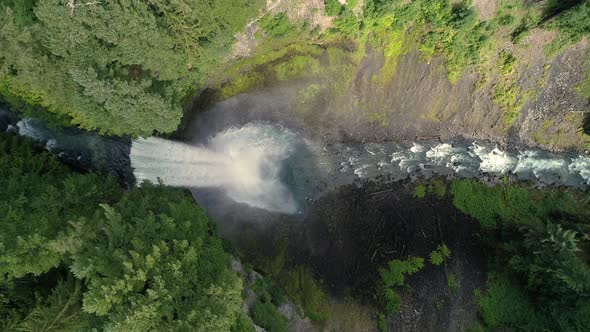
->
xmin=460 ymin=180 xmax=590 ymax=331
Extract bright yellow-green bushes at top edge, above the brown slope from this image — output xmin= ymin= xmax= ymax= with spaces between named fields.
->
xmin=326 ymin=0 xmax=493 ymax=84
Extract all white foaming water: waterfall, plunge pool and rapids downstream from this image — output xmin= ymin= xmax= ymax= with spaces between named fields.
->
xmin=9 ymin=119 xmax=590 ymax=213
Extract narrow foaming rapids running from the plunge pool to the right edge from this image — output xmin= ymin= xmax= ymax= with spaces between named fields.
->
xmin=338 ymin=142 xmax=590 ymax=188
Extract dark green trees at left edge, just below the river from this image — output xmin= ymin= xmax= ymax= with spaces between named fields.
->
xmin=0 ymin=134 xmax=120 ymax=278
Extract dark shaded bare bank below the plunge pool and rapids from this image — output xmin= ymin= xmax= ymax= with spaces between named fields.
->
xmin=217 ymin=181 xmax=486 ymax=331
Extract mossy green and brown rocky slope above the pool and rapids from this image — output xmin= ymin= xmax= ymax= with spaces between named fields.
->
xmin=205 ymin=1 xmax=590 ymax=151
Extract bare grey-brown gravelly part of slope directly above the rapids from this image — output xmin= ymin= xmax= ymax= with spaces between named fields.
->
xmin=334 ymin=38 xmax=590 ymax=150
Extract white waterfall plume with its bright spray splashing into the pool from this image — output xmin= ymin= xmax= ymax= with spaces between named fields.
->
xmin=131 ymin=125 xmax=297 ymax=213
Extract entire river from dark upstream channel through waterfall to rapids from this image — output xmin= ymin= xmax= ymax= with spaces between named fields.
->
xmin=0 ymin=97 xmax=590 ymax=214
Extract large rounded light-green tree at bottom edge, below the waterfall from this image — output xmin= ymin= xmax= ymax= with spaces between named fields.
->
xmin=71 ymin=184 xmax=242 ymax=331
